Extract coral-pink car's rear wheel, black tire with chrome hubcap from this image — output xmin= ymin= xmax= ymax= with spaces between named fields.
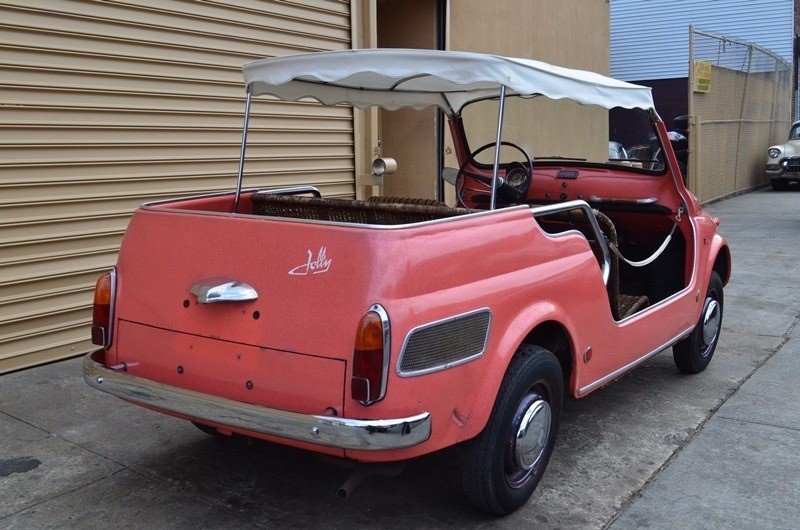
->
xmin=463 ymin=345 xmax=564 ymax=515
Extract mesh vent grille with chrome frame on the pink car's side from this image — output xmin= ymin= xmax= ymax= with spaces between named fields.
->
xmin=397 ymin=308 xmax=492 ymax=377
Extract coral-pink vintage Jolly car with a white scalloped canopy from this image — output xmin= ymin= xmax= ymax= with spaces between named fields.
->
xmin=84 ymin=49 xmax=731 ymax=514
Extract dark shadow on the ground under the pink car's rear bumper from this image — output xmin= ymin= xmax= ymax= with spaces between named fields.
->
xmin=139 ymin=424 xmax=492 ymax=527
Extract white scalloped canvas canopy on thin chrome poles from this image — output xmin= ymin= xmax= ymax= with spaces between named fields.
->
xmin=243 ymin=49 xmax=653 ymax=115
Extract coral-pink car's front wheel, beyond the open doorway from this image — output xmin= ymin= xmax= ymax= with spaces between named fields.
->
xmin=672 ymin=272 xmax=725 ymax=374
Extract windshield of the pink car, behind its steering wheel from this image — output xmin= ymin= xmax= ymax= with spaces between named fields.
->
xmin=461 ymin=97 xmax=664 ymax=172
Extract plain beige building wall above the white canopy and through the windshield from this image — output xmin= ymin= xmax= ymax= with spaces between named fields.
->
xmin=446 ymin=0 xmax=610 ymax=174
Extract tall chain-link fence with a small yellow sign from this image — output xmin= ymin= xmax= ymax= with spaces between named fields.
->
xmin=687 ymin=27 xmax=792 ymax=202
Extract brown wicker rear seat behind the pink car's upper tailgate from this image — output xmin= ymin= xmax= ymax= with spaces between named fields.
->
xmin=252 ymin=192 xmax=479 ymax=225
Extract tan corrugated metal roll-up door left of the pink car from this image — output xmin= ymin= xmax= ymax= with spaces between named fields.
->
xmin=0 ymin=0 xmax=355 ymax=373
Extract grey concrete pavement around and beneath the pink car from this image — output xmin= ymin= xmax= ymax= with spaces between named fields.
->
xmin=0 ymin=191 xmax=800 ymax=528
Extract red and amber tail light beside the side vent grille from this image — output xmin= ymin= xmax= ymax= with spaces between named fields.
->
xmin=350 ymin=304 xmax=390 ymax=405
